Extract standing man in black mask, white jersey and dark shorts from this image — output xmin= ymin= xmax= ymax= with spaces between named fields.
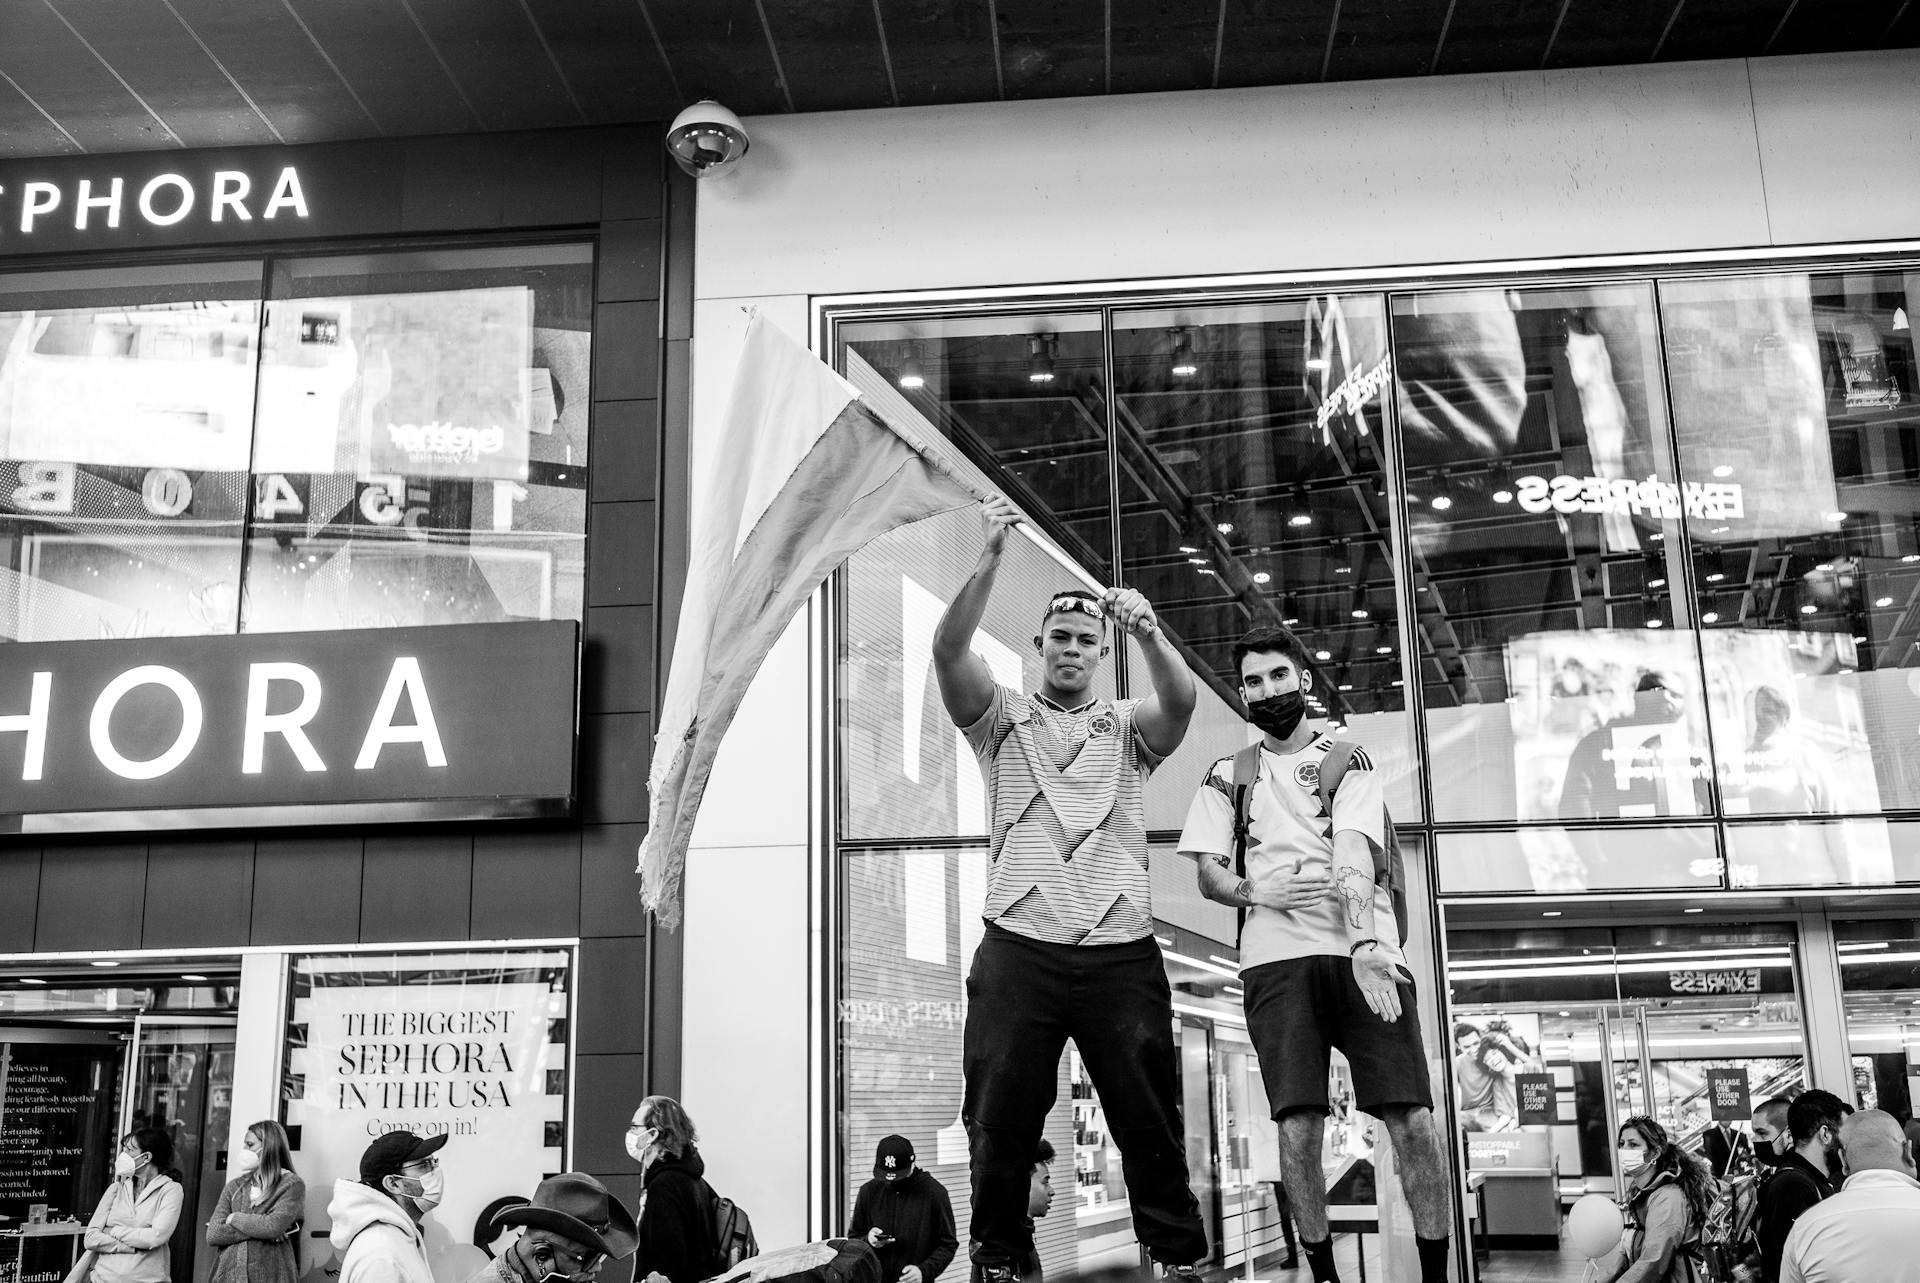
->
xmin=1179 ymin=628 xmax=1452 ymax=1283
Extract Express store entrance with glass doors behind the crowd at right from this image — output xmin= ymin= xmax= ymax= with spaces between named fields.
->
xmin=1448 ymin=910 xmax=1807 ymax=1283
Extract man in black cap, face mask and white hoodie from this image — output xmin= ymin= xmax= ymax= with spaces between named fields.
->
xmin=326 ymin=1131 xmax=447 ymax=1283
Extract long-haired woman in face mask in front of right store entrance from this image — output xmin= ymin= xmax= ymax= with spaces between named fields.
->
xmin=1594 ymin=1116 xmax=1713 ymax=1283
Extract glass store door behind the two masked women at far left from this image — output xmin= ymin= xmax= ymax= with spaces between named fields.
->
xmin=119 ymin=1014 xmax=240 ymax=1283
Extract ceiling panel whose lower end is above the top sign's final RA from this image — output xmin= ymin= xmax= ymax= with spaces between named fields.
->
xmin=44 ymin=0 xmax=278 ymax=148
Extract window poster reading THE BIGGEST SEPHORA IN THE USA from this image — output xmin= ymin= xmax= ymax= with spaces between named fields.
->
xmin=282 ymin=949 xmax=568 ymax=1283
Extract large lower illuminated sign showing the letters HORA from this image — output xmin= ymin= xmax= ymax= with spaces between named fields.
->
xmin=0 ymin=620 xmax=578 ymax=832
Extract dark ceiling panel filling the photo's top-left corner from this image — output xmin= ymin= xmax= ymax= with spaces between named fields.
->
xmin=0 ymin=0 xmax=179 ymax=152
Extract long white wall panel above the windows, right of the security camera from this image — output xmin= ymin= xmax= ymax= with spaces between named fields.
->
xmin=695 ymin=61 xmax=1789 ymax=298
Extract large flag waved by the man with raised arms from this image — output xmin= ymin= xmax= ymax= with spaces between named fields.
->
xmin=639 ymin=315 xmax=981 ymax=928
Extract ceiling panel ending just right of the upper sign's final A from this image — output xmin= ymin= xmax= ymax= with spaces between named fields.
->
xmin=167 ymin=0 xmax=374 ymax=142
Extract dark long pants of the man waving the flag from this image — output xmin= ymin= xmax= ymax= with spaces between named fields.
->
xmin=962 ymin=922 xmax=1206 ymax=1268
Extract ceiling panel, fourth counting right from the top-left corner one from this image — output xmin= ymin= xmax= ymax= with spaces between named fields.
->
xmin=280 ymin=0 xmax=476 ymax=134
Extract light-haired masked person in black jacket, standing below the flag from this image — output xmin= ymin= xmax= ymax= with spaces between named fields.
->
xmin=626 ymin=1097 xmax=724 ymax=1283
